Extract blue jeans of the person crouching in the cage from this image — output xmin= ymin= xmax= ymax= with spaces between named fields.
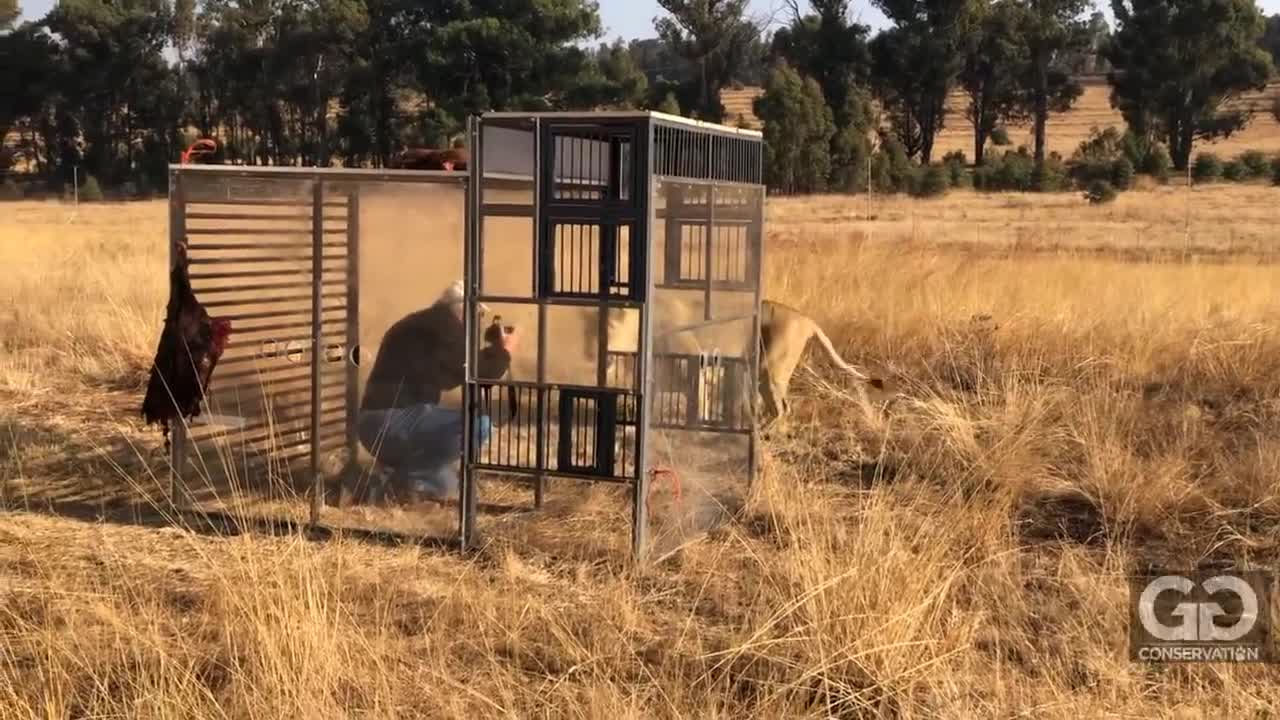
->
xmin=356 ymin=404 xmax=492 ymax=500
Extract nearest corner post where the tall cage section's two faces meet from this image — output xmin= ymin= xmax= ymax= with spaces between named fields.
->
xmin=631 ymin=119 xmax=669 ymax=562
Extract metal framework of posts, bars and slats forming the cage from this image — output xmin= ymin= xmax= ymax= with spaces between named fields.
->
xmin=160 ymin=113 xmax=764 ymax=559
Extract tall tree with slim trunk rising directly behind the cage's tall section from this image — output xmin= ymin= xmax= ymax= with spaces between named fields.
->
xmin=654 ymin=0 xmax=762 ymax=122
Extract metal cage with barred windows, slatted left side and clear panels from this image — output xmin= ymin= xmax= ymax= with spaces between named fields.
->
xmin=160 ymin=113 xmax=764 ymax=556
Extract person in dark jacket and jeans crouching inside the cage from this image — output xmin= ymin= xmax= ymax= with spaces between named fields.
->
xmin=357 ymin=282 xmax=516 ymax=502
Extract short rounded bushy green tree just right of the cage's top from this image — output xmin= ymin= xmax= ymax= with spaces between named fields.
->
xmin=755 ymin=61 xmax=836 ymax=195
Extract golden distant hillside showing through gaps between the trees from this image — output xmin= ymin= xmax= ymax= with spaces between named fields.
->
xmin=721 ymin=76 xmax=1280 ymax=160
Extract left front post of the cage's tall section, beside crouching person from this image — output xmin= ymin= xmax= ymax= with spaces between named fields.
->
xmin=458 ymin=115 xmax=484 ymax=550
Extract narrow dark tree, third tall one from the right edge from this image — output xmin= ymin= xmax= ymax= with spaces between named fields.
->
xmin=959 ymin=0 xmax=1028 ymax=165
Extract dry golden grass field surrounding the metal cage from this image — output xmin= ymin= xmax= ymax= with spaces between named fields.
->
xmin=0 ymin=188 xmax=1280 ymax=717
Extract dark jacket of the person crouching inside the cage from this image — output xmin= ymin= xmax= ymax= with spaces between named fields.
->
xmin=360 ymin=302 xmax=511 ymax=410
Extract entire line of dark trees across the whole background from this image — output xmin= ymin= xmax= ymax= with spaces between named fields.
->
xmin=0 ymin=0 xmax=1280 ymax=192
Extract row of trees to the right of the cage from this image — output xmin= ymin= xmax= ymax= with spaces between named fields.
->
xmin=756 ymin=0 xmax=1280 ymax=193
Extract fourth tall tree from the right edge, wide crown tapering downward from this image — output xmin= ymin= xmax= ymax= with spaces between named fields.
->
xmin=870 ymin=0 xmax=978 ymax=164
